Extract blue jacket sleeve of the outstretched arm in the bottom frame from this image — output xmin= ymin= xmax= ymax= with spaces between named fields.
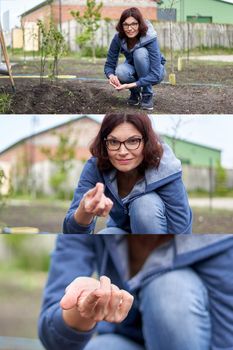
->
xmin=38 ymin=235 xmax=95 ymax=350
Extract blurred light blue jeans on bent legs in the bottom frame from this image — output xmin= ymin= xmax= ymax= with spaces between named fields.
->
xmin=84 ymin=268 xmax=211 ymax=350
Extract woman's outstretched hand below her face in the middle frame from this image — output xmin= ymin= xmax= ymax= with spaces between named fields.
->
xmin=74 ymin=182 xmax=113 ymax=225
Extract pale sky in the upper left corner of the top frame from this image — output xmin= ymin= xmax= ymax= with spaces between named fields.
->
xmin=0 ymin=0 xmax=233 ymax=28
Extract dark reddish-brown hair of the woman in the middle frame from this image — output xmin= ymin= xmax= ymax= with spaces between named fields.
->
xmin=90 ymin=112 xmax=163 ymax=173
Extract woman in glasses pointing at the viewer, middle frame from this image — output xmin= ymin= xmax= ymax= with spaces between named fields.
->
xmin=63 ymin=113 xmax=192 ymax=234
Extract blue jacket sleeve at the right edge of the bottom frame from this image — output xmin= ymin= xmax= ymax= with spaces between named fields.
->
xmin=192 ymin=241 xmax=233 ymax=350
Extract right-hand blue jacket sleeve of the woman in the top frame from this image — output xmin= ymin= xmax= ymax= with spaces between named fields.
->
xmin=136 ymin=38 xmax=166 ymax=87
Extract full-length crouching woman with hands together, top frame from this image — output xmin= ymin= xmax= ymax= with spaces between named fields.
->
xmin=104 ymin=7 xmax=166 ymax=110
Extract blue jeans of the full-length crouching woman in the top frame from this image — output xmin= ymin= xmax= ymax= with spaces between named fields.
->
xmin=116 ymin=47 xmax=164 ymax=94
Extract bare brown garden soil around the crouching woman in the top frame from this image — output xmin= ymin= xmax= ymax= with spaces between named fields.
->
xmin=0 ymin=61 xmax=233 ymax=114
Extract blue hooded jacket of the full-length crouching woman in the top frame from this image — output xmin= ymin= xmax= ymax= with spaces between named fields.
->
xmin=104 ymin=21 xmax=166 ymax=87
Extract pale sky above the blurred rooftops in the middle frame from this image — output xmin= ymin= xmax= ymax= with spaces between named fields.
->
xmin=0 ymin=115 xmax=233 ymax=169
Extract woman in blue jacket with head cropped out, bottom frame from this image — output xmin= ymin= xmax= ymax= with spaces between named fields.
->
xmin=39 ymin=234 xmax=233 ymax=350
